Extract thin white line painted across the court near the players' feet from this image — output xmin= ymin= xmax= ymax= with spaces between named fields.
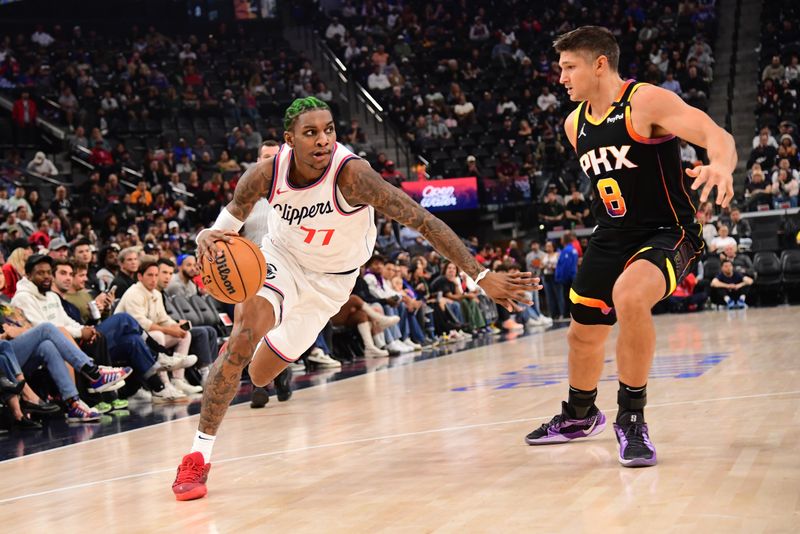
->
xmin=0 ymin=390 xmax=800 ymax=504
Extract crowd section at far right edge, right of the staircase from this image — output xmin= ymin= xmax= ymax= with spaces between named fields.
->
xmin=743 ymin=2 xmax=800 ymax=211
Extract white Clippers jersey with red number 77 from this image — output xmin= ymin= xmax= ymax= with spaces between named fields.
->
xmin=267 ymin=143 xmax=378 ymax=273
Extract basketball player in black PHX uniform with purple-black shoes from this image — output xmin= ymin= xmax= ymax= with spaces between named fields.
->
xmin=525 ymin=26 xmax=737 ymax=467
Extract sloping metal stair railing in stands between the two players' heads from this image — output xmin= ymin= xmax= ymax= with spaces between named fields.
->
xmin=295 ymin=26 xmax=416 ymax=180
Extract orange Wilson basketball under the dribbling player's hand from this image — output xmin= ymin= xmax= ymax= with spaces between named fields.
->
xmin=200 ymin=236 xmax=267 ymax=304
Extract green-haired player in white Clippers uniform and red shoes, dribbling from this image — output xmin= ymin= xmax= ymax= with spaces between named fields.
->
xmin=172 ymin=97 xmax=541 ymax=500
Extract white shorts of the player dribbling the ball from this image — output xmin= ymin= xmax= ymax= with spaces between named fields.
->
xmin=257 ymin=238 xmax=358 ymax=362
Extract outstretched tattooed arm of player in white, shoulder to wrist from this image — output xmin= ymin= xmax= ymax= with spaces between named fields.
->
xmin=338 ymin=160 xmax=483 ymax=279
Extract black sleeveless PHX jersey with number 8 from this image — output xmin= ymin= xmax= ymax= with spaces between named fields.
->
xmin=574 ymin=80 xmax=695 ymax=229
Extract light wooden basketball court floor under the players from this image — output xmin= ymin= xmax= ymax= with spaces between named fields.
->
xmin=0 ymin=307 xmax=800 ymax=533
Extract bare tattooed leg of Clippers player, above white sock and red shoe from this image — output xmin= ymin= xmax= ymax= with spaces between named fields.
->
xmin=199 ymin=297 xmax=275 ymax=435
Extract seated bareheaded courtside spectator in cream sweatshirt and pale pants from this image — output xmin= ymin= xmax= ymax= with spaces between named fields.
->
xmin=114 ymin=259 xmax=202 ymax=394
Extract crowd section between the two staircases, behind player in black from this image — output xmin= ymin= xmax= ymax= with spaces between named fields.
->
xmin=317 ymin=0 xmax=716 ymax=207
